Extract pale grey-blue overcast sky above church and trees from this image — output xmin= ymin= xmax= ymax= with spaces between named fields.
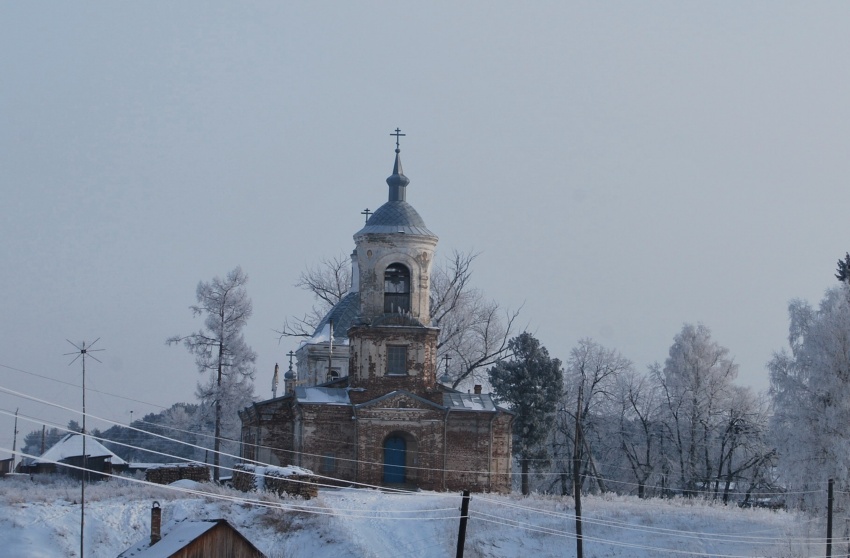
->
xmin=0 ymin=0 xmax=850 ymax=457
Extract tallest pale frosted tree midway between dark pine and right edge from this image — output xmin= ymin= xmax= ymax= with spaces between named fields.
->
xmin=655 ymin=324 xmax=738 ymax=494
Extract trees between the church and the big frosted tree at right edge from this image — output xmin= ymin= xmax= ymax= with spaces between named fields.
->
xmin=489 ymin=324 xmax=776 ymax=501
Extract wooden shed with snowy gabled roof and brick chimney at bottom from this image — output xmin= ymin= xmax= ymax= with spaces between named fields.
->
xmin=118 ymin=502 xmax=267 ymax=558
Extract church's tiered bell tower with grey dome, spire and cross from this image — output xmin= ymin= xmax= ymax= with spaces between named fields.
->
xmin=348 ymin=128 xmax=439 ymax=398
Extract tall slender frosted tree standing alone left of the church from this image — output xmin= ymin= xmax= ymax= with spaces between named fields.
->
xmin=166 ymin=267 xmax=257 ymax=481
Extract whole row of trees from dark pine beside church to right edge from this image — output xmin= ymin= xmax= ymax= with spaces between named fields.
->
xmin=488 ymin=254 xmax=850 ymax=509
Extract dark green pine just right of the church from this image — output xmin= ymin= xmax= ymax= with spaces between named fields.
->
xmin=488 ymin=333 xmax=564 ymax=495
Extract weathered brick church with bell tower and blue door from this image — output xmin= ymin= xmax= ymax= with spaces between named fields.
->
xmin=240 ymin=136 xmax=514 ymax=492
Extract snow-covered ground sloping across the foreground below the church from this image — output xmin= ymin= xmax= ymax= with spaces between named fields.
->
xmin=0 ymin=477 xmax=824 ymax=558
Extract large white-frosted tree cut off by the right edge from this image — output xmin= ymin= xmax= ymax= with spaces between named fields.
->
xmin=768 ymin=283 xmax=850 ymax=508
